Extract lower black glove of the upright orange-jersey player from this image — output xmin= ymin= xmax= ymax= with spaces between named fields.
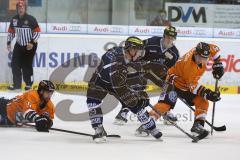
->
xmin=199 ymin=87 xmax=221 ymax=102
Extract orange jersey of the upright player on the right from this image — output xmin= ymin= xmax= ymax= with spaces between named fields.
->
xmin=168 ymin=44 xmax=220 ymax=94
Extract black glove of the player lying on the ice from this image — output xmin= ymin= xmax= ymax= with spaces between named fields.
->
xmin=35 ymin=115 xmax=49 ymax=132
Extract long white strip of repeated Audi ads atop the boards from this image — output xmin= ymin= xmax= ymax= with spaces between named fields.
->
xmin=0 ymin=22 xmax=240 ymax=39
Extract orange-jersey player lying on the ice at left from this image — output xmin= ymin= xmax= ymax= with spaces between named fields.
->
xmin=0 ymin=80 xmax=55 ymax=132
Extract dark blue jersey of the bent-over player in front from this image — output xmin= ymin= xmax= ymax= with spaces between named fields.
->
xmin=90 ymin=47 xmax=131 ymax=96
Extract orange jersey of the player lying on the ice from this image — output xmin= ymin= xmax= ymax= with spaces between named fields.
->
xmin=7 ymin=90 xmax=55 ymax=124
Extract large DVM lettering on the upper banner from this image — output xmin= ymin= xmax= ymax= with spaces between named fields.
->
xmin=168 ymin=6 xmax=207 ymax=23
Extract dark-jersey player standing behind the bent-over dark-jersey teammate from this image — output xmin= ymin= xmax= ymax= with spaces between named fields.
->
xmin=114 ymin=26 xmax=179 ymax=125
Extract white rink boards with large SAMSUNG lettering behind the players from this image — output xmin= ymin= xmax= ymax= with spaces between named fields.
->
xmin=0 ymin=33 xmax=240 ymax=94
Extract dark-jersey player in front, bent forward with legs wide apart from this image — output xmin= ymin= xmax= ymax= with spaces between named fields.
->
xmin=87 ymin=37 xmax=165 ymax=142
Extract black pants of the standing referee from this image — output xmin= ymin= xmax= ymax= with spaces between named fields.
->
xmin=11 ymin=43 xmax=37 ymax=88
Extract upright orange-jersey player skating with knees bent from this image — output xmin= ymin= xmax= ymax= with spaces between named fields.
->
xmin=137 ymin=42 xmax=224 ymax=138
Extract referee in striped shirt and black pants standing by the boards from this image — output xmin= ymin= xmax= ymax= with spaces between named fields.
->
xmin=7 ymin=0 xmax=40 ymax=90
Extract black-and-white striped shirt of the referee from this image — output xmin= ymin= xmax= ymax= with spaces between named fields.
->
xmin=7 ymin=14 xmax=40 ymax=46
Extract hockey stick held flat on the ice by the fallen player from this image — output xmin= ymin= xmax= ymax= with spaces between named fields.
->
xmin=23 ymin=123 xmax=121 ymax=138
